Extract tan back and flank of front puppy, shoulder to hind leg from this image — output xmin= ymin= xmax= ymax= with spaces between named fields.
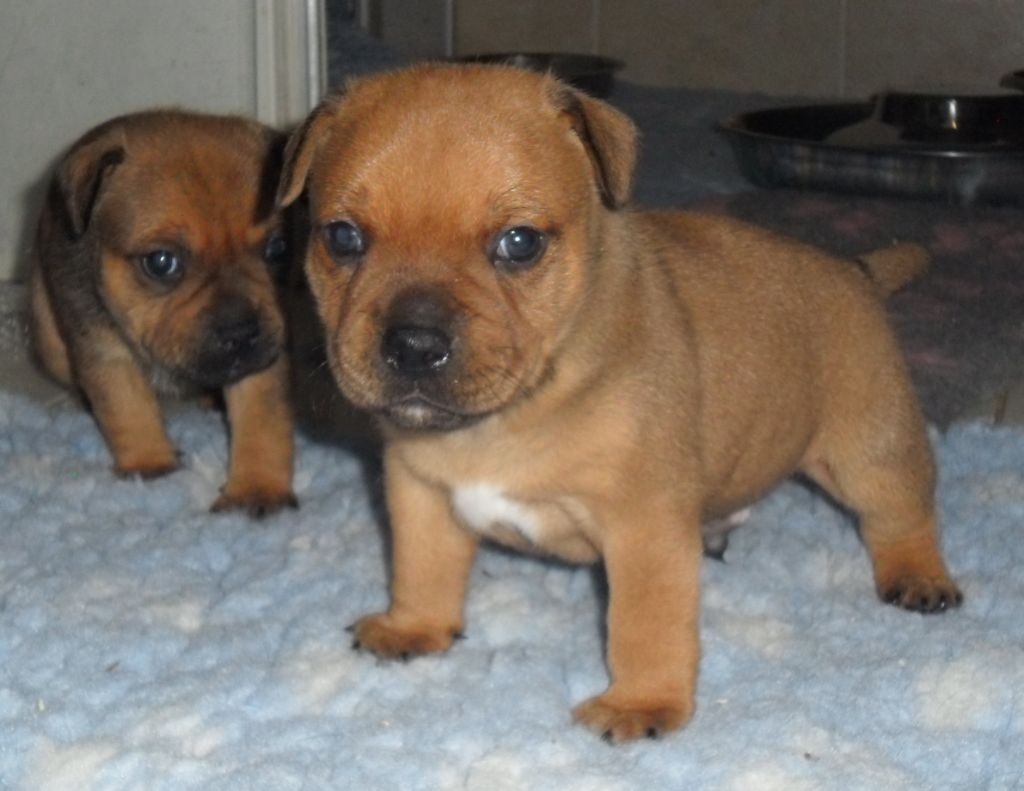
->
xmin=640 ymin=213 xmax=913 ymax=507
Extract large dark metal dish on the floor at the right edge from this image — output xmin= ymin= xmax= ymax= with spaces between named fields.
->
xmin=719 ymin=92 xmax=1024 ymax=205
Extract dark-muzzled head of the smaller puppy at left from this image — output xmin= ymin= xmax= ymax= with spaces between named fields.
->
xmin=51 ymin=111 xmax=289 ymax=388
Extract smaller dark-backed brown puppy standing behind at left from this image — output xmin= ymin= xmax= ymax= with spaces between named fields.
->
xmin=31 ymin=111 xmax=296 ymax=515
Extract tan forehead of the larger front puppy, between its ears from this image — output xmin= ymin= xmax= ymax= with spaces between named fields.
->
xmin=310 ymin=70 xmax=593 ymax=224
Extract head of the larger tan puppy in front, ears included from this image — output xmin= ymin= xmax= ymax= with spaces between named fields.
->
xmin=279 ymin=66 xmax=635 ymax=428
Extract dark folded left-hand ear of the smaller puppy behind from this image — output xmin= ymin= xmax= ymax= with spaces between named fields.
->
xmin=54 ymin=125 xmax=125 ymax=239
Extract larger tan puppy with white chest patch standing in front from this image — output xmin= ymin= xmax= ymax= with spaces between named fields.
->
xmin=279 ymin=66 xmax=961 ymax=742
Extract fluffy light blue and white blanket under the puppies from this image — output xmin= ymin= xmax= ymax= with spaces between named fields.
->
xmin=0 ymin=392 xmax=1024 ymax=791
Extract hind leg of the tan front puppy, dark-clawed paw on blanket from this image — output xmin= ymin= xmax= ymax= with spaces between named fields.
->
xmin=803 ymin=408 xmax=963 ymax=613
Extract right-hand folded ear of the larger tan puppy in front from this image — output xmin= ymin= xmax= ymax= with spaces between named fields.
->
xmin=549 ymin=80 xmax=637 ymax=209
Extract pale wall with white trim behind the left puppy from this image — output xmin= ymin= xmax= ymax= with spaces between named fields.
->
xmin=0 ymin=0 xmax=316 ymax=280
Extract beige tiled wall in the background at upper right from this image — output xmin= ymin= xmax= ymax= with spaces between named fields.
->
xmin=454 ymin=0 xmax=1024 ymax=96
